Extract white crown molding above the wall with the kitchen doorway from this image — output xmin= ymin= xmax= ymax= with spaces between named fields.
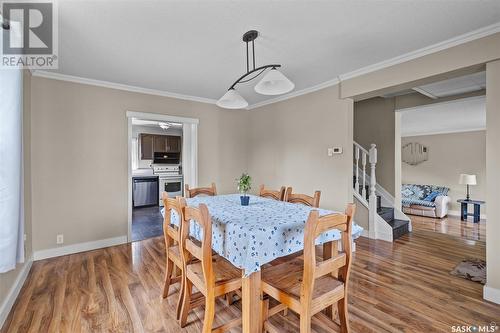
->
xmin=32 ymin=70 xmax=216 ymax=104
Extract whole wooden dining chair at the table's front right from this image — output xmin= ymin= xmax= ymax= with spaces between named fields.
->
xmin=262 ymin=204 xmax=356 ymax=333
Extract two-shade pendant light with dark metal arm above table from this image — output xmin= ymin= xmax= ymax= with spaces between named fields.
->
xmin=217 ymin=30 xmax=295 ymax=109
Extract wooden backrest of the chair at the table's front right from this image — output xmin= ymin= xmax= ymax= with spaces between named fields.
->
xmin=300 ymin=204 xmax=356 ymax=304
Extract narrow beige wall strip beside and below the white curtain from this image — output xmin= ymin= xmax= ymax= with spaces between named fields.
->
xmin=0 ymin=71 xmax=33 ymax=326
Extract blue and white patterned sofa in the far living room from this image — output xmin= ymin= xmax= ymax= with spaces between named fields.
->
xmin=401 ymin=184 xmax=451 ymax=218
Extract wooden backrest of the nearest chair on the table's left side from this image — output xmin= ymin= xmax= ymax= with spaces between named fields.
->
xmin=180 ymin=204 xmax=215 ymax=289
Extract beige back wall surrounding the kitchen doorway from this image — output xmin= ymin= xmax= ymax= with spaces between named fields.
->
xmin=31 ymin=77 xmax=248 ymax=251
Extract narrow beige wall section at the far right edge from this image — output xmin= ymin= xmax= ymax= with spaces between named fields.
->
xmin=486 ymin=61 xmax=500 ymax=294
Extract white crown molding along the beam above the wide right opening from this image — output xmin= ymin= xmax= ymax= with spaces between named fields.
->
xmin=339 ymin=22 xmax=500 ymax=81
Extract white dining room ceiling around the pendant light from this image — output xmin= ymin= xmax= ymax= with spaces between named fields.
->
xmin=39 ymin=0 xmax=500 ymax=105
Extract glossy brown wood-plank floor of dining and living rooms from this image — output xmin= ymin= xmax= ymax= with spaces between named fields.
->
xmin=2 ymin=214 xmax=500 ymax=333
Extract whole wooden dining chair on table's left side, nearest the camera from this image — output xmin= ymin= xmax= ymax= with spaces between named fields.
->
xmin=180 ymin=198 xmax=242 ymax=333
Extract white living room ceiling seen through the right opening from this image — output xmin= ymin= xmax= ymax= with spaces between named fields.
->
xmin=398 ymin=96 xmax=486 ymax=136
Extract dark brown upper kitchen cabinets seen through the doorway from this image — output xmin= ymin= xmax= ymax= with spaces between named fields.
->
xmin=139 ymin=133 xmax=182 ymax=160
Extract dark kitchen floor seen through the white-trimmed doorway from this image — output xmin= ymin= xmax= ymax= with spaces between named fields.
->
xmin=132 ymin=206 xmax=163 ymax=242
